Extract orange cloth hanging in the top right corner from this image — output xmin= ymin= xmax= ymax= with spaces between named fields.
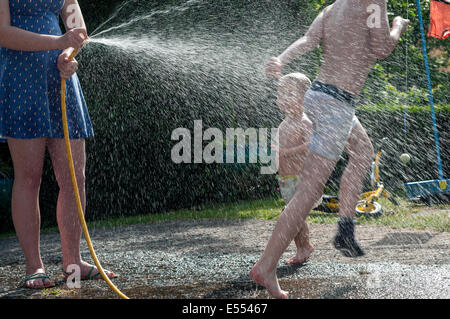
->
xmin=428 ymin=0 xmax=450 ymax=40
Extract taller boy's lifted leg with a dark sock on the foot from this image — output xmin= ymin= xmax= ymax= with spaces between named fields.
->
xmin=334 ymin=121 xmax=374 ymax=257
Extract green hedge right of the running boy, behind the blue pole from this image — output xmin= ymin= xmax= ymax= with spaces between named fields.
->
xmin=331 ymin=106 xmax=450 ymax=195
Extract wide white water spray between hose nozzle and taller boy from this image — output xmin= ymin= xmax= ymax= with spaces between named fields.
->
xmin=81 ymin=0 xmax=319 ymax=131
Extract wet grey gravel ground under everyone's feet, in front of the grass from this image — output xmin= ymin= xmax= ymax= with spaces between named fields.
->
xmin=0 ymin=219 xmax=450 ymax=299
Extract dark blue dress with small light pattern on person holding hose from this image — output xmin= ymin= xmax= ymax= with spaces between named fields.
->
xmin=0 ymin=0 xmax=94 ymax=139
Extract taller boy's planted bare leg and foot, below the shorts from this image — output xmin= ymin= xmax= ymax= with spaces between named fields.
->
xmin=250 ymin=152 xmax=336 ymax=298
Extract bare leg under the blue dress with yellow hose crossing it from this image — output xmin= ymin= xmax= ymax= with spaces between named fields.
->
xmin=48 ymin=139 xmax=114 ymax=278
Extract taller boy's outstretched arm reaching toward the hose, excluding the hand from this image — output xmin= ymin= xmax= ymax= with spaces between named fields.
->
xmin=278 ymin=11 xmax=324 ymax=66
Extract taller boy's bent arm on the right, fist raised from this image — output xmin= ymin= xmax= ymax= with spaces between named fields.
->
xmin=368 ymin=0 xmax=409 ymax=60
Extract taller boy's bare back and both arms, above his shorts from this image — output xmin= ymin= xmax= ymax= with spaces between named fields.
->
xmin=269 ymin=0 xmax=409 ymax=96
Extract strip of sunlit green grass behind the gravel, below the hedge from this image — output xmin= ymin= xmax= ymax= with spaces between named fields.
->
xmin=0 ymin=198 xmax=450 ymax=237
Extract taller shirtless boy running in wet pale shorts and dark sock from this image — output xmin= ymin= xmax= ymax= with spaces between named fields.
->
xmin=250 ymin=0 xmax=409 ymax=298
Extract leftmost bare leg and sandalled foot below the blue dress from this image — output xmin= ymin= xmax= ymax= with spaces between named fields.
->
xmin=8 ymin=138 xmax=53 ymax=288
